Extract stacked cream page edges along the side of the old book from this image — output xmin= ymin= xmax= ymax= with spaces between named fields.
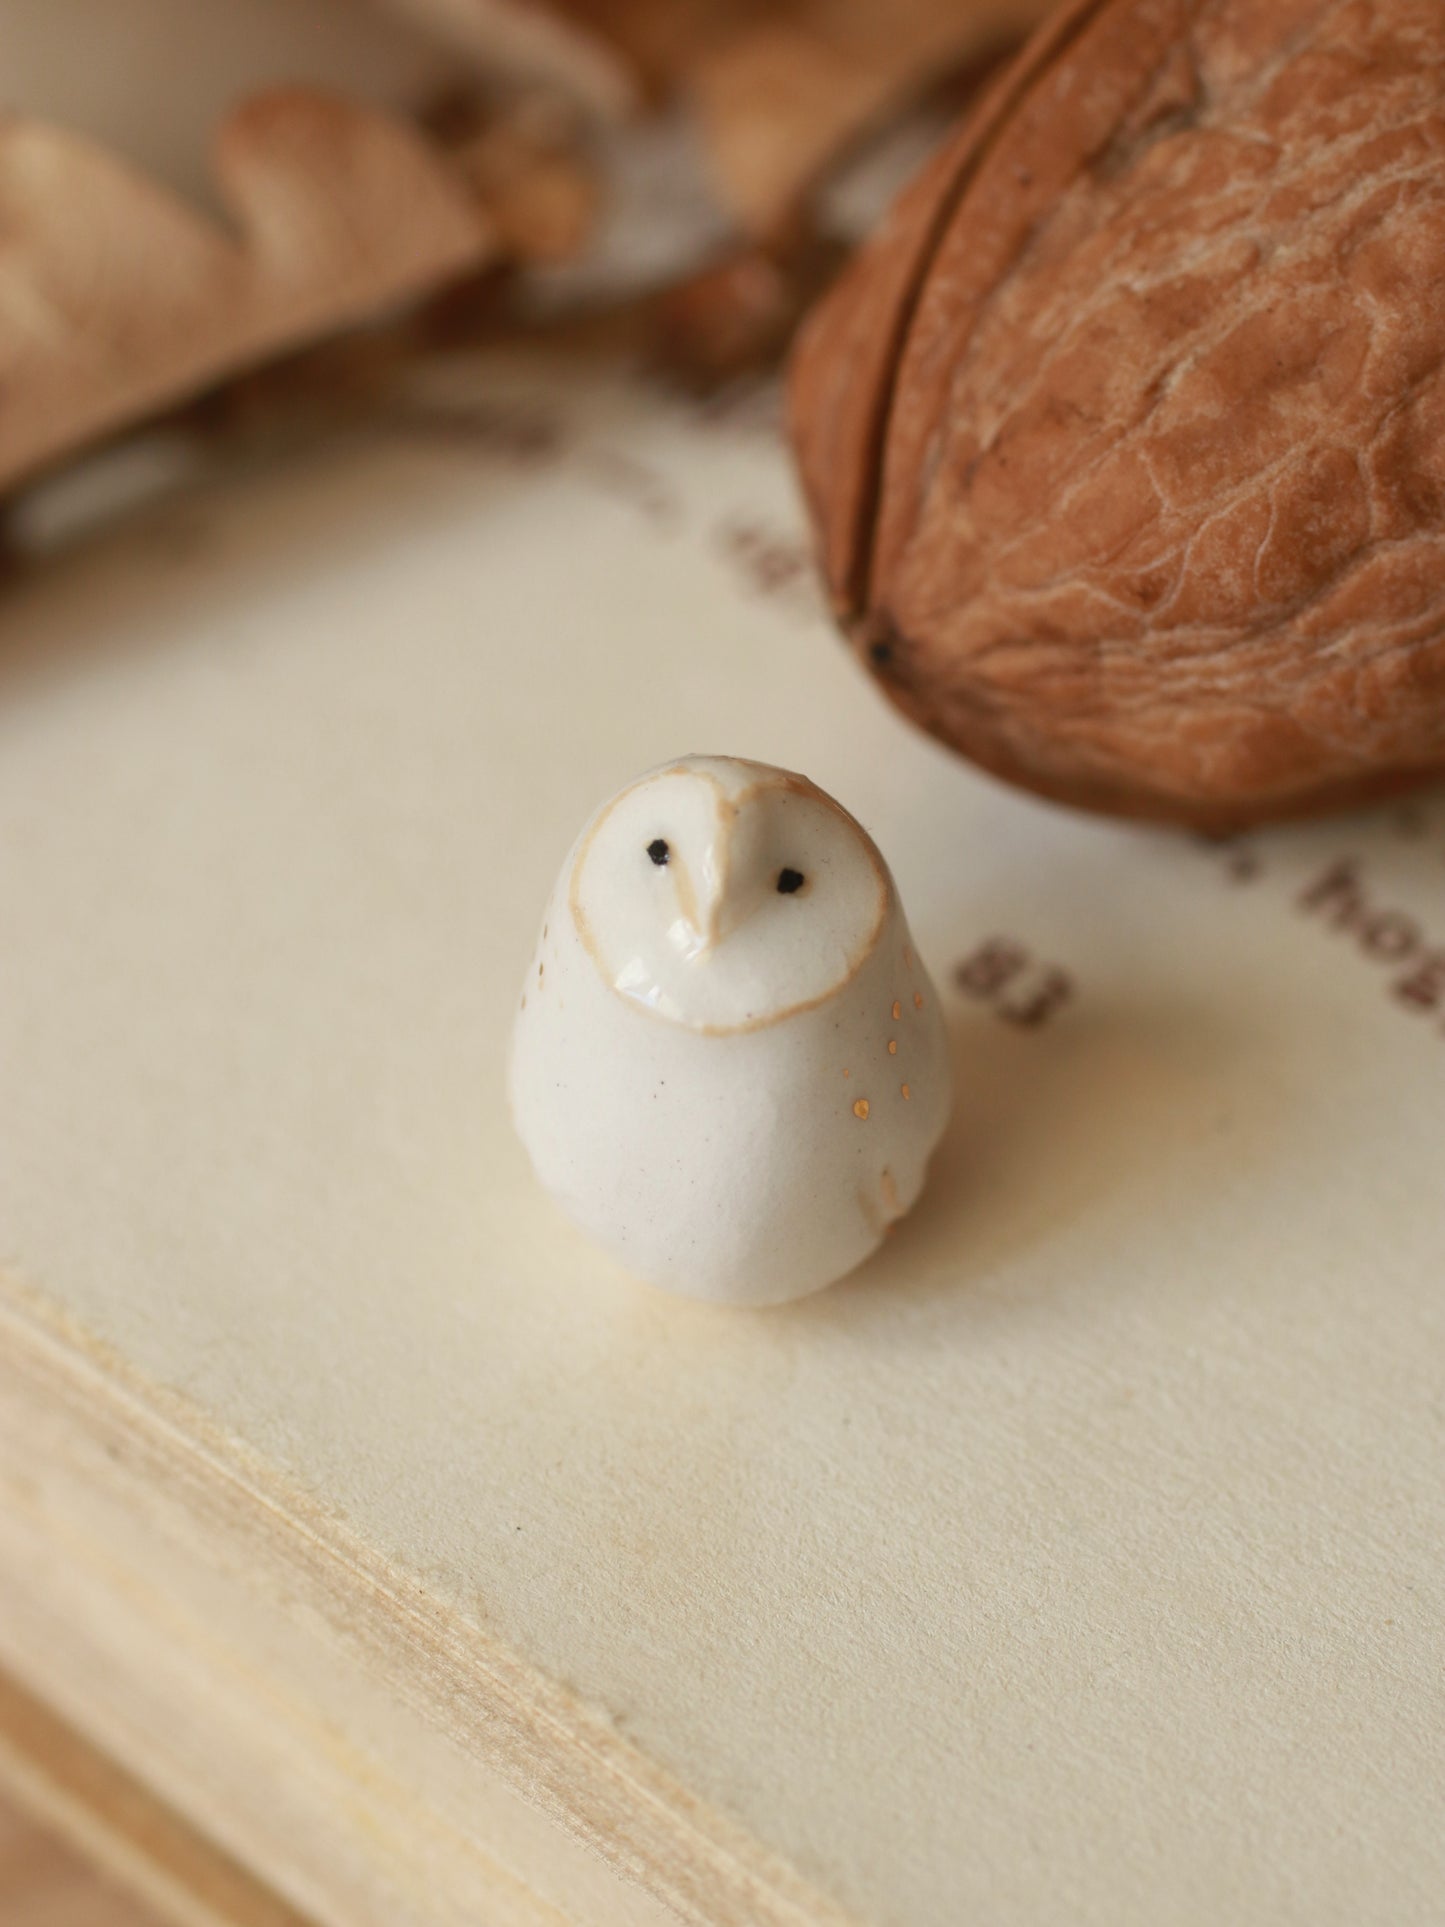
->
xmin=0 ymin=1270 xmax=824 ymax=1927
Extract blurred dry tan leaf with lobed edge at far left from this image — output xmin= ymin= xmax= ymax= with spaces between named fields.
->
xmin=0 ymin=89 xmax=495 ymax=488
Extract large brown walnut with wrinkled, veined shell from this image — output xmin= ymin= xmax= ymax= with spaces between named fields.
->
xmin=790 ymin=0 xmax=1445 ymax=829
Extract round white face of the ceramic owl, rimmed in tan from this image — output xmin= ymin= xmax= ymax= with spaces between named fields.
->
xmin=570 ymin=757 xmax=892 ymax=1033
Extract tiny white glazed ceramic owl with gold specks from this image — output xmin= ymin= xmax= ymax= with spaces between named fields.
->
xmin=511 ymin=755 xmax=950 ymax=1305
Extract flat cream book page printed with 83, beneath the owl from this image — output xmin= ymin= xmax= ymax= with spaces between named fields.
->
xmin=0 ymin=362 xmax=1445 ymax=1927
